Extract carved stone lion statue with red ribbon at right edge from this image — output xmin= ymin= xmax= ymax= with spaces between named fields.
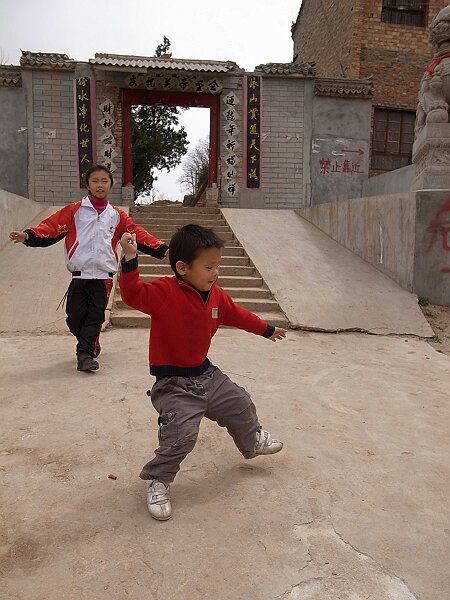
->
xmin=415 ymin=5 xmax=450 ymax=138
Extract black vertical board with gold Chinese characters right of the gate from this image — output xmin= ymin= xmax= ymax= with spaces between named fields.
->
xmin=247 ymin=75 xmax=261 ymax=189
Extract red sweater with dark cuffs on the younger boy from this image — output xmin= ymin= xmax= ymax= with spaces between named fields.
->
xmin=120 ymin=260 xmax=268 ymax=375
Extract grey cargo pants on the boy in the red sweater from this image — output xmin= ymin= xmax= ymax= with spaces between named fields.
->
xmin=140 ymin=365 xmax=259 ymax=484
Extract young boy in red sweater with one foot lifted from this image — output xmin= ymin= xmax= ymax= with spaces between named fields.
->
xmin=120 ymin=225 xmax=286 ymax=521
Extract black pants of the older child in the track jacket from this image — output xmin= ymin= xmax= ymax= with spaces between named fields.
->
xmin=66 ymin=278 xmax=112 ymax=358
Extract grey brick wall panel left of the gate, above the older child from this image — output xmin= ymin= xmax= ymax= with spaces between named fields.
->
xmin=30 ymin=69 xmax=81 ymax=204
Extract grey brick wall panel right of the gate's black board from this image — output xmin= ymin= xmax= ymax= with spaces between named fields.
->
xmin=261 ymin=77 xmax=305 ymax=208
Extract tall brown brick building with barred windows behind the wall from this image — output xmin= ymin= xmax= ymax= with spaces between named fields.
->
xmin=292 ymin=0 xmax=448 ymax=175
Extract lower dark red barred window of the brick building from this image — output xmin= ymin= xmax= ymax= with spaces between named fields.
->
xmin=371 ymin=108 xmax=416 ymax=171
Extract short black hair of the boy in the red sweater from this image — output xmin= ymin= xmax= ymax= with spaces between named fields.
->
xmin=169 ymin=223 xmax=225 ymax=273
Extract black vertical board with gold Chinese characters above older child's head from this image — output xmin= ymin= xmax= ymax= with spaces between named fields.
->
xmin=75 ymin=77 xmax=93 ymax=187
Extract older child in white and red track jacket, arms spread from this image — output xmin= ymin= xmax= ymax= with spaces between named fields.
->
xmin=9 ymin=165 xmax=168 ymax=371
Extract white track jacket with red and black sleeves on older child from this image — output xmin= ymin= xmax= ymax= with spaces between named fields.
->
xmin=24 ymin=196 xmax=168 ymax=279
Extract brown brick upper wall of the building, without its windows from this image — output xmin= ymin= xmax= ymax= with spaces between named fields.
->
xmin=292 ymin=0 xmax=448 ymax=110
